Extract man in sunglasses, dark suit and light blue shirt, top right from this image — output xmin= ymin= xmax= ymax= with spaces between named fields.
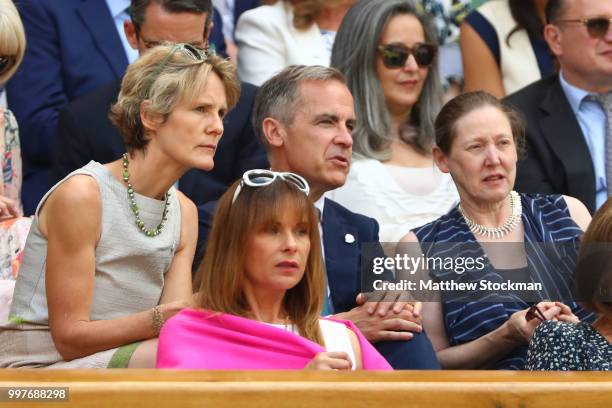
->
xmin=506 ymin=0 xmax=612 ymax=213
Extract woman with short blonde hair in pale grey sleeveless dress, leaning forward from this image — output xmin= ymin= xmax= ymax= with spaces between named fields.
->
xmin=0 ymin=44 xmax=239 ymax=368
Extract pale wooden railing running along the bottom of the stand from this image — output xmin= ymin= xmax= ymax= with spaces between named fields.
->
xmin=0 ymin=369 xmax=612 ymax=408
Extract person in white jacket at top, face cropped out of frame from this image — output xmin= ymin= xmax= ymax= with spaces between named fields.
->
xmin=235 ymin=0 xmax=355 ymax=85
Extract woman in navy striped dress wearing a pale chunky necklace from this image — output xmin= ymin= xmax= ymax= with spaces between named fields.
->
xmin=402 ymin=92 xmax=591 ymax=369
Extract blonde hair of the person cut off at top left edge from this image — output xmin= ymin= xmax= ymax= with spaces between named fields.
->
xmin=0 ymin=0 xmax=26 ymax=84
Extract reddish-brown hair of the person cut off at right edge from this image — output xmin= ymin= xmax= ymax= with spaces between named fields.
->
xmin=576 ymin=199 xmax=612 ymax=315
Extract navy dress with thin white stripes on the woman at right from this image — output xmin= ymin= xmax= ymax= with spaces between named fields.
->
xmin=414 ymin=194 xmax=593 ymax=370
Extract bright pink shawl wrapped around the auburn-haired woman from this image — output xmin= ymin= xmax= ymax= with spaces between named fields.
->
xmin=157 ymin=309 xmax=392 ymax=370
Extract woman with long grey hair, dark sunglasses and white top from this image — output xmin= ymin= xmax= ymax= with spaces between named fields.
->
xmin=328 ymin=0 xmax=458 ymax=242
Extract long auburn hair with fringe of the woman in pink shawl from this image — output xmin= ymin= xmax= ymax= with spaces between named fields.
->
xmin=196 ymin=179 xmax=325 ymax=345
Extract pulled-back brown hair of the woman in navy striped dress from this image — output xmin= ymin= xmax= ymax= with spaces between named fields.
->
xmin=434 ymin=91 xmax=525 ymax=156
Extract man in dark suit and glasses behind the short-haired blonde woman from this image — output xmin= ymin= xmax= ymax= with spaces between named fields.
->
xmin=53 ymin=0 xmax=267 ymax=209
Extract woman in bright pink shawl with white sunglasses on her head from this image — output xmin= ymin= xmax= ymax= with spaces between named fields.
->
xmin=157 ymin=170 xmax=390 ymax=370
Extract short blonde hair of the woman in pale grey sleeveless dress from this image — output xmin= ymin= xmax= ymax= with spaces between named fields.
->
xmin=109 ymin=44 xmax=240 ymax=152
